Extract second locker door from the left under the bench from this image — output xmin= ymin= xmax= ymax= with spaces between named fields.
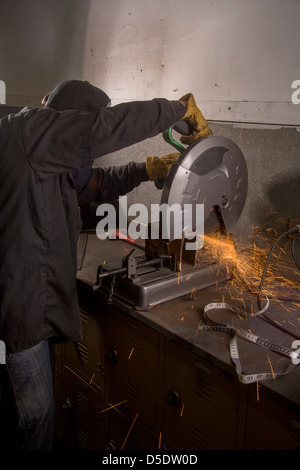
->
xmin=106 ymin=309 xmax=163 ymax=449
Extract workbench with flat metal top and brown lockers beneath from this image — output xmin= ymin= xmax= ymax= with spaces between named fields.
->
xmin=55 ymin=233 xmax=300 ymax=450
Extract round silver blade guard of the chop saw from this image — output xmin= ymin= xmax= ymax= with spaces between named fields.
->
xmin=161 ymin=136 xmax=248 ymax=240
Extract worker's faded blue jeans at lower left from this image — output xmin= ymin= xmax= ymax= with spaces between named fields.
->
xmin=1 ymin=340 xmax=55 ymax=450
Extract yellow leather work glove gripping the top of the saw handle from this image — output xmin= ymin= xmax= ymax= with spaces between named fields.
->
xmin=180 ymin=93 xmax=212 ymax=144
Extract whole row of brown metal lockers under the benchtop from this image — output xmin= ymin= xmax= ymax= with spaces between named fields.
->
xmin=55 ymin=298 xmax=300 ymax=450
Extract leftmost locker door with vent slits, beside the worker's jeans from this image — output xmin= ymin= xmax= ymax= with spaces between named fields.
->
xmin=55 ymin=307 xmax=106 ymax=450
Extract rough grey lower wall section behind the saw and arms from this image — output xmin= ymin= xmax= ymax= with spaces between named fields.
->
xmin=95 ymin=122 xmax=300 ymax=243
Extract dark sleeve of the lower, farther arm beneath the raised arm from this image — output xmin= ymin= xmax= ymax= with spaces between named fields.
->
xmin=72 ymin=162 xmax=149 ymax=206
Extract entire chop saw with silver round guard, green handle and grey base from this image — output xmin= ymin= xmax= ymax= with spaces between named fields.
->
xmin=94 ymin=121 xmax=248 ymax=309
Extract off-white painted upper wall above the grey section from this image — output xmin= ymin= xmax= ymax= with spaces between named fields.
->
xmin=0 ymin=0 xmax=300 ymax=125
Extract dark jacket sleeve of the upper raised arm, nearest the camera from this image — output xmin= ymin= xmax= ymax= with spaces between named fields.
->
xmin=21 ymin=99 xmax=185 ymax=178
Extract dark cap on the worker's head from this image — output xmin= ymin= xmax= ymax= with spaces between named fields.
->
xmin=42 ymin=80 xmax=110 ymax=111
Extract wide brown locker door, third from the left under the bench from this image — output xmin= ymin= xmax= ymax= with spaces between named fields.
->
xmin=162 ymin=341 xmax=239 ymax=450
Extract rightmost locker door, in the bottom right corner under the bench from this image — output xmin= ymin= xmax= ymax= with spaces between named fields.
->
xmin=245 ymin=386 xmax=300 ymax=450
